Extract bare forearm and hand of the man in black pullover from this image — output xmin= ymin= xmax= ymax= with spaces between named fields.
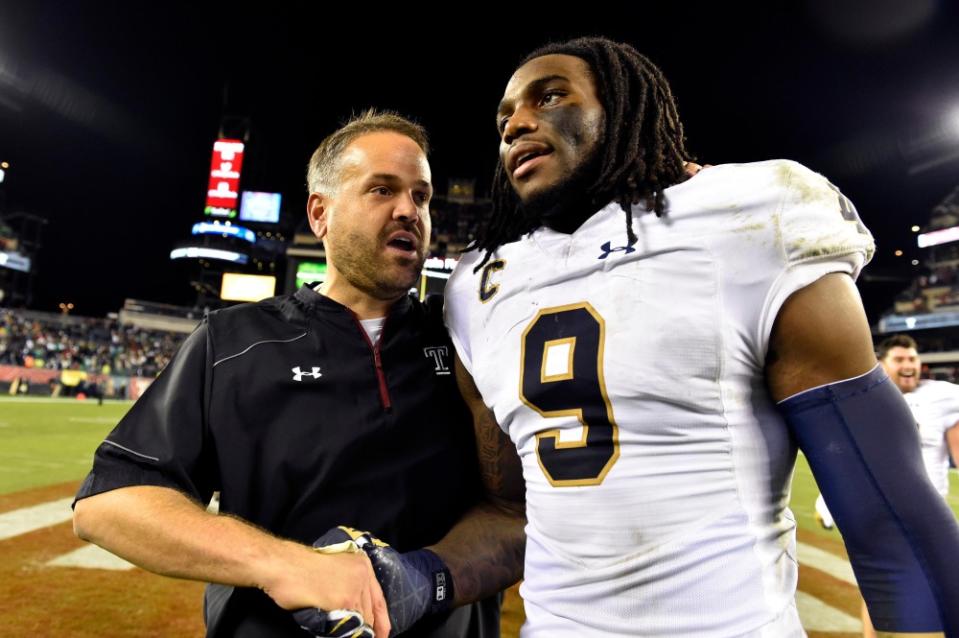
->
xmin=73 ymin=485 xmax=389 ymax=636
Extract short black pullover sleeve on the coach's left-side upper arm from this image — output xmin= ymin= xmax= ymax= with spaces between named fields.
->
xmin=77 ymin=322 xmax=217 ymax=510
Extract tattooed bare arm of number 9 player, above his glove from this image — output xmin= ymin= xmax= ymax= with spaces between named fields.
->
xmin=430 ymin=357 xmax=526 ymax=604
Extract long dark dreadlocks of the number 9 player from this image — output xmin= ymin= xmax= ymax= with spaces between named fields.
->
xmin=467 ymin=37 xmax=690 ymax=269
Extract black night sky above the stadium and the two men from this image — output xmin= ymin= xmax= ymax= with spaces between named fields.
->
xmin=0 ymin=0 xmax=959 ymax=320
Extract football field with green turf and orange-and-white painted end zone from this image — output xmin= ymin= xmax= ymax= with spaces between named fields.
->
xmin=0 ymin=398 xmax=959 ymax=638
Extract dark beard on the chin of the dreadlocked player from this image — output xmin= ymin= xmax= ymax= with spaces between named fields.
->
xmin=516 ymin=144 xmax=600 ymax=233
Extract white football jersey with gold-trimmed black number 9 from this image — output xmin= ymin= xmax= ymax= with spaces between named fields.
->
xmin=446 ymin=160 xmax=873 ymax=638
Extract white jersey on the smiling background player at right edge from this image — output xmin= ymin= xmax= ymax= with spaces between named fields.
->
xmin=903 ymin=381 xmax=959 ymax=496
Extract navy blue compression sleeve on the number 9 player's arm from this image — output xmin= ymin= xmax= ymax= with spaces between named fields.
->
xmin=779 ymin=366 xmax=959 ymax=636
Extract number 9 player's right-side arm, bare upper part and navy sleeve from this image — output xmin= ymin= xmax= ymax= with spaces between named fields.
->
xmin=766 ymin=273 xmax=959 ymax=636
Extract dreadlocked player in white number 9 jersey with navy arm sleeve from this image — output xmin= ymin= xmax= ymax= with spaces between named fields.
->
xmin=447 ymin=38 xmax=959 ymax=638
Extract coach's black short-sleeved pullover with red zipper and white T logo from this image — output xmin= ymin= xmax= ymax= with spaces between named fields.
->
xmin=77 ymin=286 xmax=498 ymax=636
